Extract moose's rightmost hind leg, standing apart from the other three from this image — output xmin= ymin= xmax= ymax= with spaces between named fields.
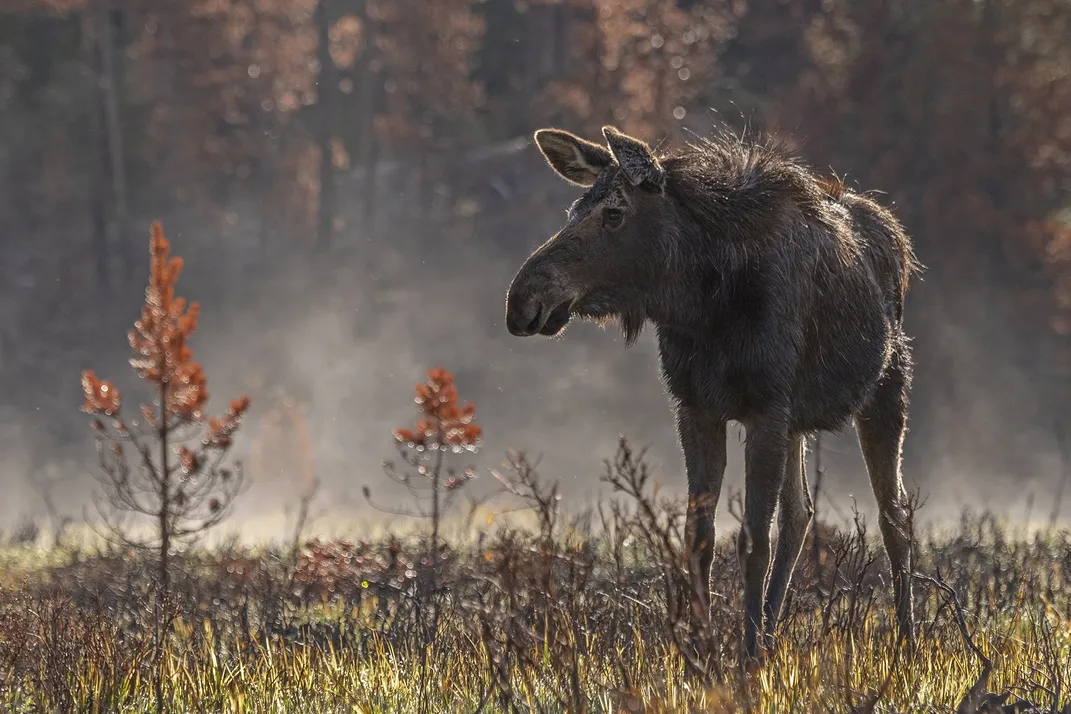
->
xmin=856 ymin=346 xmax=915 ymax=643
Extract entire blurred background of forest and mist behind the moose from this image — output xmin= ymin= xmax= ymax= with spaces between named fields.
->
xmin=0 ymin=0 xmax=1071 ymax=535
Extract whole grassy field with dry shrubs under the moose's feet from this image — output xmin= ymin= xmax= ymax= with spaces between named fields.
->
xmin=0 ymin=447 xmax=1071 ymax=714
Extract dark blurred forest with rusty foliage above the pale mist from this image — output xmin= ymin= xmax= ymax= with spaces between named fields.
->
xmin=0 ymin=0 xmax=1071 ymax=492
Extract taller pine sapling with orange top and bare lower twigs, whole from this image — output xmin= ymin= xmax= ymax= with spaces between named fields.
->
xmin=81 ymin=223 xmax=250 ymax=711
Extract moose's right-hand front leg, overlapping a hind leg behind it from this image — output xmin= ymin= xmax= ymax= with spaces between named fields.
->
xmin=737 ymin=416 xmax=789 ymax=659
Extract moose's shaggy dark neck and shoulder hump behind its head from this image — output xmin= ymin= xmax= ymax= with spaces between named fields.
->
xmin=604 ymin=141 xmax=828 ymax=346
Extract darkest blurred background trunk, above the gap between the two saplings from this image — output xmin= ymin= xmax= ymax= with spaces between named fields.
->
xmin=316 ymin=0 xmax=338 ymax=249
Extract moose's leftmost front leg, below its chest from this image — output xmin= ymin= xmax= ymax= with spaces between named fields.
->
xmin=677 ymin=406 xmax=726 ymax=622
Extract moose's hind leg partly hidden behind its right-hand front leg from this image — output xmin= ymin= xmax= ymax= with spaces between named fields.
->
xmin=765 ymin=436 xmax=814 ymax=648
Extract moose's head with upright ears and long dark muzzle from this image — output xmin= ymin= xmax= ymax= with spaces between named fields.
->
xmin=506 ymin=126 xmax=673 ymax=341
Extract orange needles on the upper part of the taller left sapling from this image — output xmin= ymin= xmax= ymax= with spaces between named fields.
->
xmin=81 ymin=222 xmax=250 ymax=432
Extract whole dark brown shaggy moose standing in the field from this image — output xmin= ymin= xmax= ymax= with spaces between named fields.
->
xmin=506 ymin=126 xmax=921 ymax=662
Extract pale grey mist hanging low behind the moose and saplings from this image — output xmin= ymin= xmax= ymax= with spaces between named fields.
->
xmin=2 ymin=140 xmax=1061 ymax=536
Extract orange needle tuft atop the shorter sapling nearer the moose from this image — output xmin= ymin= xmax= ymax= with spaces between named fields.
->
xmin=394 ymin=367 xmax=483 ymax=451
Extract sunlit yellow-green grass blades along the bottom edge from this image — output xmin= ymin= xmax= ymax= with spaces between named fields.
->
xmin=3 ymin=590 xmax=1071 ymax=714
